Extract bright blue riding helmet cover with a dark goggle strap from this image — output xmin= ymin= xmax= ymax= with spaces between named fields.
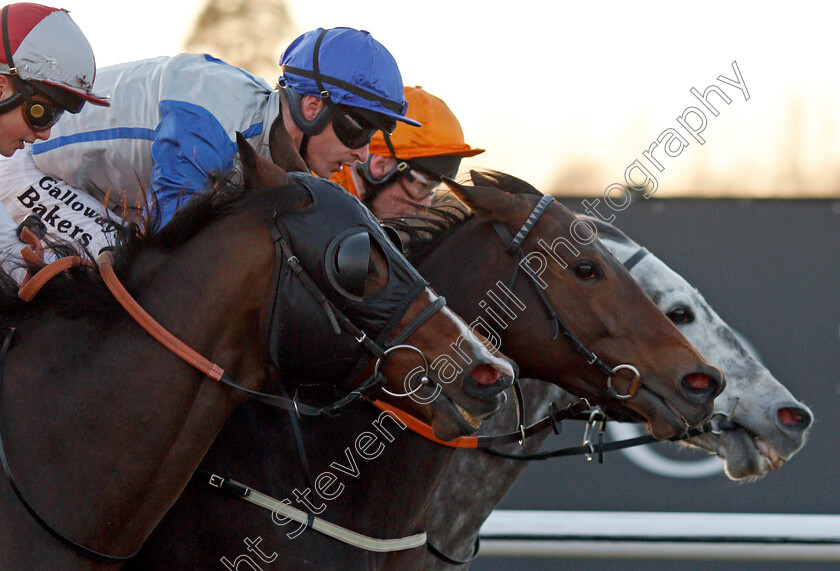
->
xmin=279 ymin=28 xmax=420 ymax=126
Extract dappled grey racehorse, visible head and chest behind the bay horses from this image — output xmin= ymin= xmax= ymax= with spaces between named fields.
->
xmin=426 ymin=220 xmax=813 ymax=569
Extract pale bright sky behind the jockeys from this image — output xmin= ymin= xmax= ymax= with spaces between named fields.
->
xmin=52 ymin=0 xmax=840 ymax=196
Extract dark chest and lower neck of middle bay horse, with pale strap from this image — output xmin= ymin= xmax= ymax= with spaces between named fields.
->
xmin=141 ymin=401 xmax=460 ymax=568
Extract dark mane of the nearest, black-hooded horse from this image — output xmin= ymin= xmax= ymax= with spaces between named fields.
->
xmin=0 ymin=177 xmax=309 ymax=322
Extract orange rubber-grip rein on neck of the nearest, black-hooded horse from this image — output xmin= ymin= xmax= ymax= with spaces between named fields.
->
xmin=18 ymin=232 xmax=225 ymax=381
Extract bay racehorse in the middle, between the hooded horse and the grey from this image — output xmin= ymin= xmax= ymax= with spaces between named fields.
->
xmin=131 ymin=169 xmax=723 ymax=569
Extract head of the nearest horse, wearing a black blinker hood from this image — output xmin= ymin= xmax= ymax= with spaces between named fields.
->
xmin=238 ymin=138 xmax=515 ymax=439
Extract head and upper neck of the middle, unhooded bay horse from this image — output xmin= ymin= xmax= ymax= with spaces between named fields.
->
xmin=402 ymin=171 xmax=724 ymax=438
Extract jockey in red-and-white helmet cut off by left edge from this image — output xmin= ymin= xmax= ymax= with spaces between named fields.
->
xmin=0 ymin=3 xmax=109 ymax=278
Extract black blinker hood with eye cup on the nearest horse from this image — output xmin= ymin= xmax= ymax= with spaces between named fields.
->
xmin=269 ymin=173 xmax=428 ymax=384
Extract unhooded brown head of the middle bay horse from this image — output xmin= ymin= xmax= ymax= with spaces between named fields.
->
xmin=434 ymin=171 xmax=724 ymax=438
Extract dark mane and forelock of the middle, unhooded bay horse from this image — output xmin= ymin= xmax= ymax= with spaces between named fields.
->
xmin=382 ymin=170 xmax=543 ymax=264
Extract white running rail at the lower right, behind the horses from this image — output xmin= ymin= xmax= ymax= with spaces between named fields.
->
xmin=481 ymin=510 xmax=840 ymax=561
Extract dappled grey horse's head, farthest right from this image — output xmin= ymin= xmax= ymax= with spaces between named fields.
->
xmin=591 ymin=219 xmax=814 ymax=479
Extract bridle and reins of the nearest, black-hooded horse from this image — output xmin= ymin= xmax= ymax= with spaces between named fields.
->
xmin=0 ymin=194 xmax=446 ymax=563
